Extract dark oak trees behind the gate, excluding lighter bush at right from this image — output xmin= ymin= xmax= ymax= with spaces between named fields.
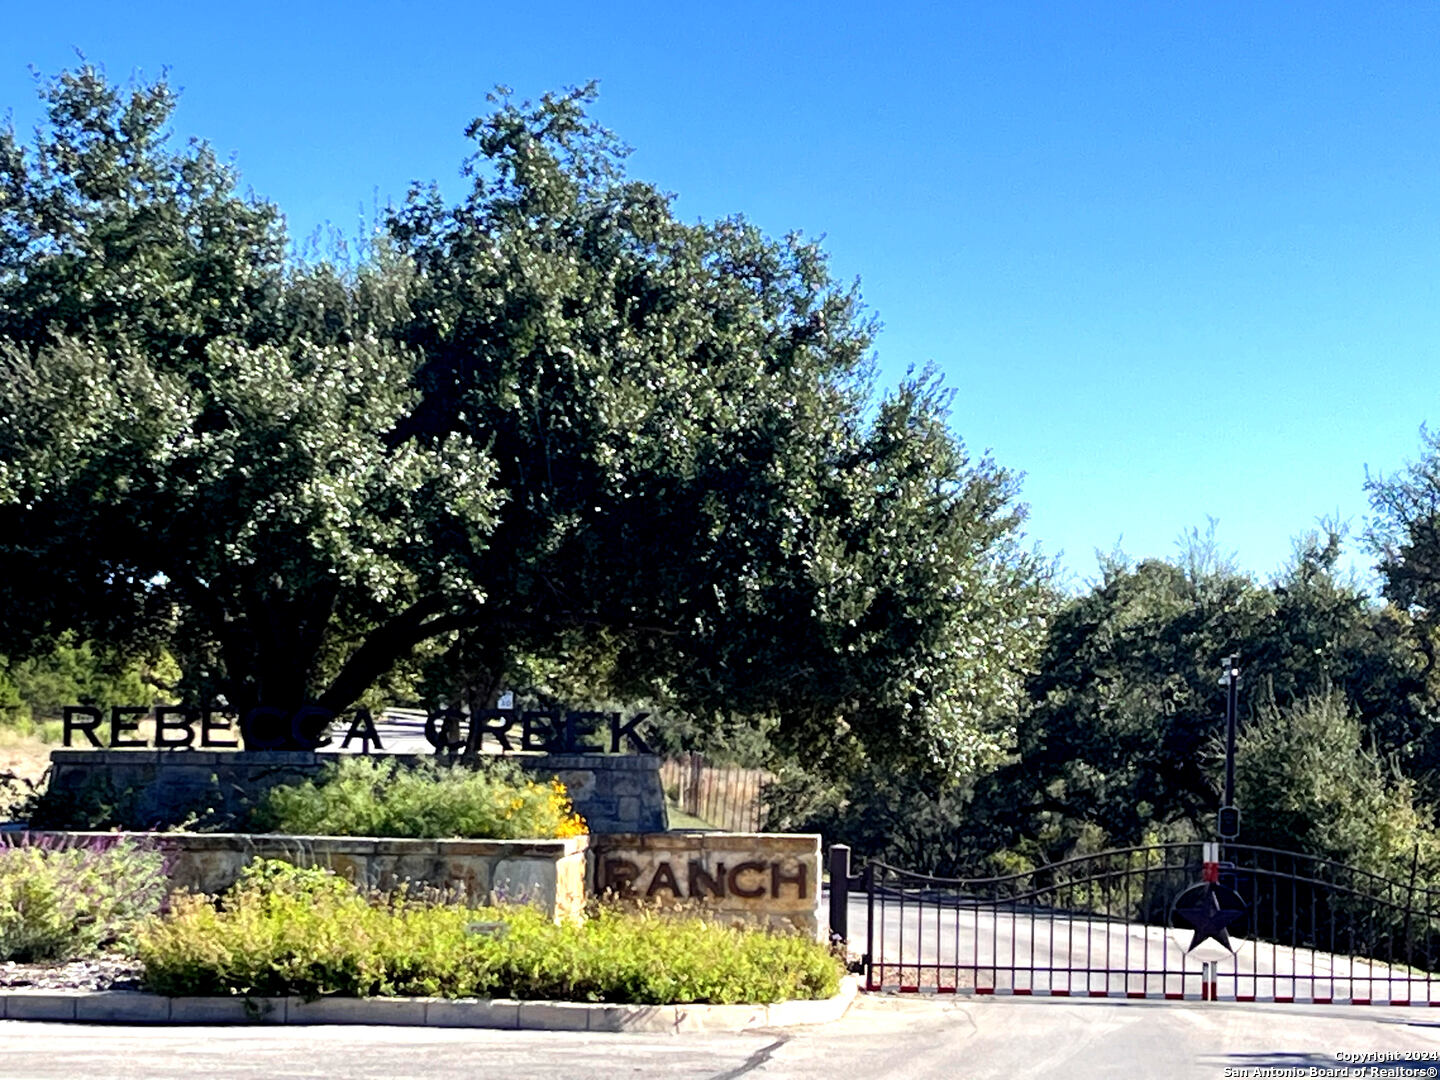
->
xmin=1008 ymin=537 xmax=1437 ymax=854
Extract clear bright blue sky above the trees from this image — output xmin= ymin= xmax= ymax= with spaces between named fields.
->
xmin=0 ymin=0 xmax=1440 ymax=593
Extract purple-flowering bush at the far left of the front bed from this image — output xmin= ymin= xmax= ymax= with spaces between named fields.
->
xmin=0 ymin=841 xmax=166 ymax=960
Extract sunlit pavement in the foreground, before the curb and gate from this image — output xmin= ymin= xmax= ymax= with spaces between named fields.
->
xmin=8 ymin=996 xmax=1440 ymax=1080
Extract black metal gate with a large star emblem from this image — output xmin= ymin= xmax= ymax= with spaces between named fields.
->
xmin=829 ymin=842 xmax=1440 ymax=1005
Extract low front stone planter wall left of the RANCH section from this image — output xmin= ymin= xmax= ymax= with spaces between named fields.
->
xmin=11 ymin=831 xmax=589 ymax=919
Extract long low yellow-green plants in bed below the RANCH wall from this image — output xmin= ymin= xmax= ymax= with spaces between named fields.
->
xmin=138 ymin=861 xmax=841 ymax=1005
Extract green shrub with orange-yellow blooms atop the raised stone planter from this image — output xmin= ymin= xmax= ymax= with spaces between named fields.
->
xmin=253 ymin=756 xmax=586 ymax=840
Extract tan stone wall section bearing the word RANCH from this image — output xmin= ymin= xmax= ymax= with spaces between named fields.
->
xmin=589 ymin=832 xmax=827 ymax=940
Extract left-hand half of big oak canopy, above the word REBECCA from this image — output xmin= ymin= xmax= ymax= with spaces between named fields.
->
xmin=0 ymin=68 xmax=500 ymax=743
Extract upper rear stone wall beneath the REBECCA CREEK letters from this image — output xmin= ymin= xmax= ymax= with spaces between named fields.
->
xmin=48 ymin=750 xmax=670 ymax=834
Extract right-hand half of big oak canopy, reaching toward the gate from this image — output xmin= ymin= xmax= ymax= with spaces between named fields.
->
xmin=390 ymin=91 xmax=1038 ymax=768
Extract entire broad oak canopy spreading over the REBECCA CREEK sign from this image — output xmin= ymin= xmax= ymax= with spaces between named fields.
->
xmin=0 ymin=68 xmax=1045 ymax=772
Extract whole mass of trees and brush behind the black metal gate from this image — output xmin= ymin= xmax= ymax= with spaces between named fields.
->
xmin=812 ymin=533 xmax=1440 ymax=876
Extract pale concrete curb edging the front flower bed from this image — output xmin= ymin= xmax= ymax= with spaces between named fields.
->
xmin=0 ymin=978 xmax=858 ymax=1034
